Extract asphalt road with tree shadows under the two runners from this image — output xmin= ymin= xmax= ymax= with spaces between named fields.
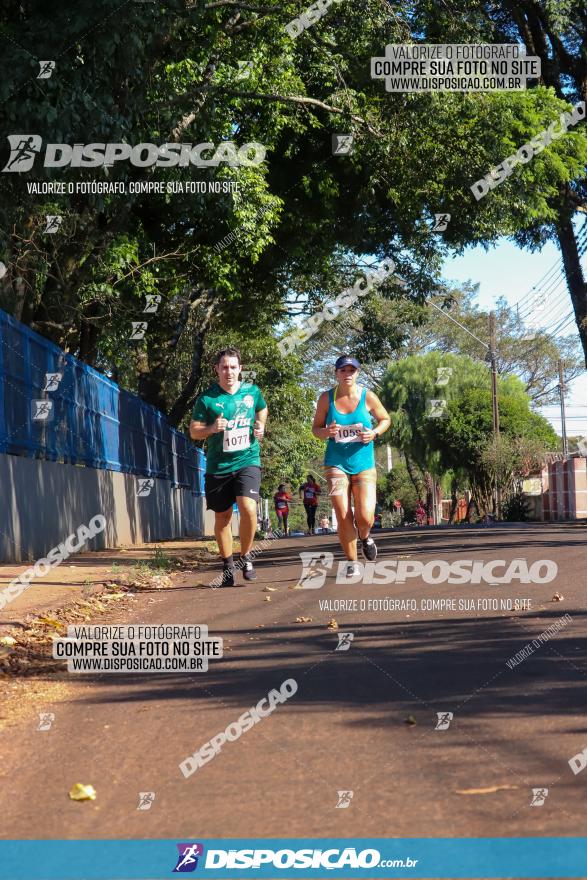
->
xmin=0 ymin=524 xmax=587 ymax=840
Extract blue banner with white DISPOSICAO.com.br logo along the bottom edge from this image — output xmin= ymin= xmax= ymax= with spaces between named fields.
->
xmin=0 ymin=837 xmax=587 ymax=880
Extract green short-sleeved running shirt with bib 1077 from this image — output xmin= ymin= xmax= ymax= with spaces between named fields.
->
xmin=192 ymin=382 xmax=267 ymax=474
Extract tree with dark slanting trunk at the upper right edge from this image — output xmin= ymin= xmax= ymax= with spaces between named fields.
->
xmin=401 ymin=0 xmax=587 ymax=365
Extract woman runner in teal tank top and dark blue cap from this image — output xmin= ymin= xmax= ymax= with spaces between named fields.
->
xmin=312 ymin=355 xmax=391 ymax=577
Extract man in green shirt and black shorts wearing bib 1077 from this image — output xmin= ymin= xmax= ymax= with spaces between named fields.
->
xmin=190 ymin=348 xmax=267 ymax=587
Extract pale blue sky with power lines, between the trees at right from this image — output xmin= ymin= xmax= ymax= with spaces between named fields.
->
xmin=443 ymin=239 xmax=587 ymax=436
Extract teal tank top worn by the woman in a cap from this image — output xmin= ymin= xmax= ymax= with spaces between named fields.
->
xmin=324 ymin=388 xmax=375 ymax=474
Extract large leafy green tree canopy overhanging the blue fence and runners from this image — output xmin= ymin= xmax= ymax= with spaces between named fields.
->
xmin=0 ymin=0 xmax=587 ymax=424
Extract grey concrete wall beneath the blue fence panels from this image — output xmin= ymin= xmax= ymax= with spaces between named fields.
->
xmin=0 ymin=453 xmax=204 ymax=562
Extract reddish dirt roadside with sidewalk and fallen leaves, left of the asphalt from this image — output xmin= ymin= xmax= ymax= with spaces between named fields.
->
xmin=0 ymin=539 xmax=224 ymax=730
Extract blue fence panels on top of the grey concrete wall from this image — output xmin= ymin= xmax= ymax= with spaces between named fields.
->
xmin=0 ymin=309 xmax=206 ymax=495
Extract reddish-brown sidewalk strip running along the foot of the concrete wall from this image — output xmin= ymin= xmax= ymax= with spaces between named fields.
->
xmin=0 ymin=538 xmax=218 ymax=636
